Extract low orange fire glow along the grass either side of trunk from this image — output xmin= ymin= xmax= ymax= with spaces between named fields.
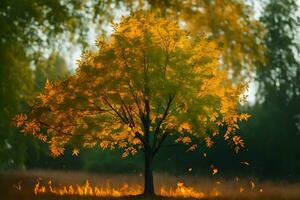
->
xmin=12 ymin=178 xmax=265 ymax=199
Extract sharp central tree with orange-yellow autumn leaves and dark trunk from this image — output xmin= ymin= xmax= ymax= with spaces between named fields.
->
xmin=14 ymin=11 xmax=249 ymax=195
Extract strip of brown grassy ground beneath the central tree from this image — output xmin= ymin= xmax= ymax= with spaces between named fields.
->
xmin=0 ymin=170 xmax=300 ymax=200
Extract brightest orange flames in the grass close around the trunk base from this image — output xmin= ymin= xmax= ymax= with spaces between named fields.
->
xmin=34 ymin=179 xmax=214 ymax=198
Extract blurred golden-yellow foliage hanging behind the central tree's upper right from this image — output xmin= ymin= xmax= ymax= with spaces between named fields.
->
xmin=145 ymin=0 xmax=264 ymax=79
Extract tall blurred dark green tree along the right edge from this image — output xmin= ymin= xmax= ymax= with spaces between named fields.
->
xmin=243 ymin=0 xmax=300 ymax=180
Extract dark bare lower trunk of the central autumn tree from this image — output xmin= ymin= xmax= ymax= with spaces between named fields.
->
xmin=143 ymin=149 xmax=155 ymax=196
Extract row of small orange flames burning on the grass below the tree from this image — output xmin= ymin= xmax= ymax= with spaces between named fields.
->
xmin=20 ymin=178 xmax=263 ymax=199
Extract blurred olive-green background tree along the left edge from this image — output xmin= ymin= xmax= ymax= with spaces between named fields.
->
xmin=0 ymin=0 xmax=79 ymax=168
